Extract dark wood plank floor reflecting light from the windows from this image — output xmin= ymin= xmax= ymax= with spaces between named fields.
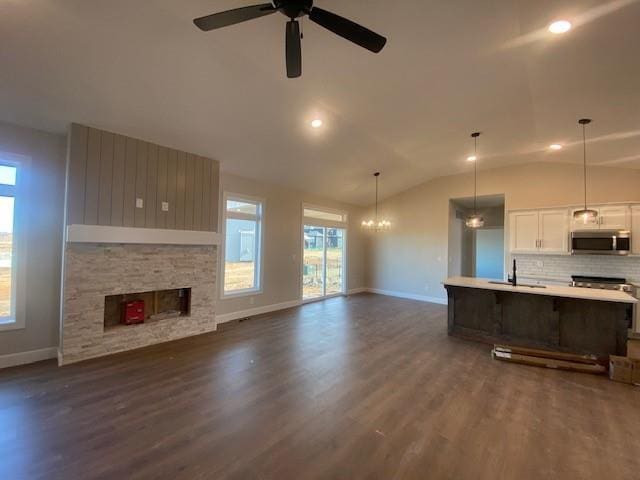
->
xmin=0 ymin=294 xmax=640 ymax=480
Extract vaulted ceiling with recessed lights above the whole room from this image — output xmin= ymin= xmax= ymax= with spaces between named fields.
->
xmin=0 ymin=0 xmax=640 ymax=204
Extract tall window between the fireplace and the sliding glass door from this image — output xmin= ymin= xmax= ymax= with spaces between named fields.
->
xmin=223 ymin=194 xmax=263 ymax=296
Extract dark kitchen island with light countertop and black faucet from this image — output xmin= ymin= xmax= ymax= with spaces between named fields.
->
xmin=444 ymin=277 xmax=637 ymax=356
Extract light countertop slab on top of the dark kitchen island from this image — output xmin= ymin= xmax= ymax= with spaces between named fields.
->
xmin=443 ymin=277 xmax=638 ymax=303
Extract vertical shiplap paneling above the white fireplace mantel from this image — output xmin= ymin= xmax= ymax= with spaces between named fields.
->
xmin=67 ymin=123 xmax=220 ymax=231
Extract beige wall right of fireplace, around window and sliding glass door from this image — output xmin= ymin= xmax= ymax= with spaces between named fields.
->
xmin=217 ymin=172 xmax=365 ymax=315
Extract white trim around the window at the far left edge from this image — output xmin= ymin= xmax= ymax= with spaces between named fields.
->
xmin=0 ymin=152 xmax=31 ymax=332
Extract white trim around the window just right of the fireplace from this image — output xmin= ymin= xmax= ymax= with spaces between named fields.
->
xmin=220 ymin=191 xmax=266 ymax=300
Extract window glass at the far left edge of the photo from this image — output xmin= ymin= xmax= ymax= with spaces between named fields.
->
xmin=0 ymin=163 xmax=18 ymax=324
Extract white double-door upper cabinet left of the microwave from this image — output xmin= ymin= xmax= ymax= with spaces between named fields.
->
xmin=509 ymin=209 xmax=569 ymax=254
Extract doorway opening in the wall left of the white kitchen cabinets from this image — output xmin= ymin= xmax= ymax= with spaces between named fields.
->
xmin=448 ymin=195 xmax=505 ymax=279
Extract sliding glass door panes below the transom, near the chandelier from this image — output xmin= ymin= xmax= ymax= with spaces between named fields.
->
xmin=302 ymin=225 xmax=345 ymax=300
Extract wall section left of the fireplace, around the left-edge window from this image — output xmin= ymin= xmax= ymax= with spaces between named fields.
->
xmin=0 ymin=123 xmax=66 ymax=355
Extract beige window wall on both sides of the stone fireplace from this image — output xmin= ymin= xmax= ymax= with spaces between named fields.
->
xmin=0 ymin=123 xmax=365 ymax=355
